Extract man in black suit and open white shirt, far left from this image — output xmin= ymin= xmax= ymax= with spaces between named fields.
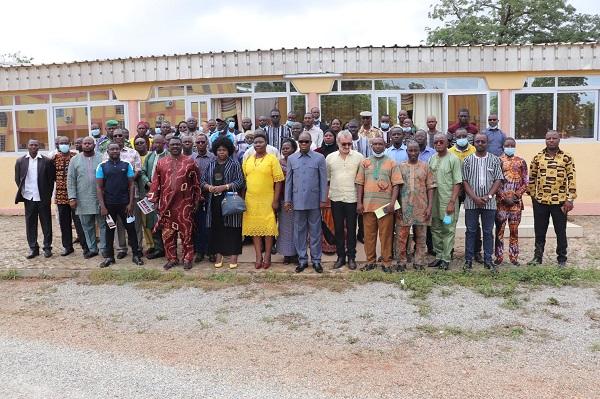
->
xmin=15 ymin=139 xmax=56 ymax=259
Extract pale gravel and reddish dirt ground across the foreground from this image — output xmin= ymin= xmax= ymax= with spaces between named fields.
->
xmin=0 ymin=280 xmax=600 ymax=398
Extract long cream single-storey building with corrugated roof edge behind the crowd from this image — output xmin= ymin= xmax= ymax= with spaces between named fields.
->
xmin=0 ymin=43 xmax=600 ymax=214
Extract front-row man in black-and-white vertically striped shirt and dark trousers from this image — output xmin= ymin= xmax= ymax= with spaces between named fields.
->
xmin=463 ymin=134 xmax=504 ymax=272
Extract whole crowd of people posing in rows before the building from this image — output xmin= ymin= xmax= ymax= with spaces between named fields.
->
xmin=15 ymin=108 xmax=576 ymax=273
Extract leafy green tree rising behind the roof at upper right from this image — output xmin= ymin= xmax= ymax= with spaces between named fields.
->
xmin=427 ymin=0 xmax=600 ymax=46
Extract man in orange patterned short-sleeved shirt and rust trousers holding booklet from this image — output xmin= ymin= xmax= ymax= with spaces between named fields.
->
xmin=355 ymin=137 xmax=404 ymax=271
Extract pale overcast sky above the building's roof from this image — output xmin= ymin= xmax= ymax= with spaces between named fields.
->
xmin=0 ymin=0 xmax=598 ymax=63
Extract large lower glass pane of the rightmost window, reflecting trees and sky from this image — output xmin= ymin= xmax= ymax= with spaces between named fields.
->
xmin=556 ymin=91 xmax=596 ymax=138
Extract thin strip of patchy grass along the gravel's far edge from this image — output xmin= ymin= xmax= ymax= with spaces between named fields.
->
xmin=63 ymin=267 xmax=600 ymax=300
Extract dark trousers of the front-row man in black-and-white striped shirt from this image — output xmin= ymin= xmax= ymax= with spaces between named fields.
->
xmin=465 ymin=208 xmax=496 ymax=263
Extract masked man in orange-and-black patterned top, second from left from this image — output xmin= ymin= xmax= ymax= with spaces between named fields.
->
xmin=54 ymin=136 xmax=89 ymax=256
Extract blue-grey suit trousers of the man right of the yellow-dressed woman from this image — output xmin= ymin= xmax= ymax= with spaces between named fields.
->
xmin=294 ymin=208 xmax=323 ymax=265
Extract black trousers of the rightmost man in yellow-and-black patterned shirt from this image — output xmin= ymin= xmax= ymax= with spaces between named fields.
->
xmin=531 ymin=200 xmax=567 ymax=262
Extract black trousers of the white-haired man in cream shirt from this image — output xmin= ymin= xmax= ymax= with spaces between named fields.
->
xmin=331 ymin=201 xmax=357 ymax=259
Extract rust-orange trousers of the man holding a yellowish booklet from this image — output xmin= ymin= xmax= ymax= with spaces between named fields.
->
xmin=363 ymin=212 xmax=394 ymax=265
